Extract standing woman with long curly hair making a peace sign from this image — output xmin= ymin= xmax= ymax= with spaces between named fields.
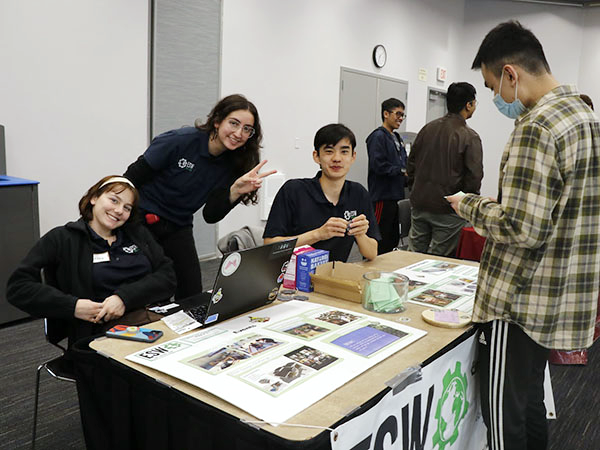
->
xmin=125 ymin=94 xmax=276 ymax=299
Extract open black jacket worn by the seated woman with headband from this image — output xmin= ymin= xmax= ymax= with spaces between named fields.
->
xmin=6 ymin=219 xmax=176 ymax=345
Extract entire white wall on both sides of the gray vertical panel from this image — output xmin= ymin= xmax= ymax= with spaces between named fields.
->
xmin=0 ymin=0 xmax=600 ymax=244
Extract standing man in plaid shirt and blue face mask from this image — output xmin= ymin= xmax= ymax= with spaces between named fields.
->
xmin=447 ymin=21 xmax=600 ymax=450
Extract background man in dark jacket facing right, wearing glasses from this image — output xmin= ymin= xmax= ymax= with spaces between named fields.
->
xmin=367 ymin=98 xmax=406 ymax=255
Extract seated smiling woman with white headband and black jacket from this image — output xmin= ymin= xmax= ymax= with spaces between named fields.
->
xmin=7 ymin=176 xmax=175 ymax=346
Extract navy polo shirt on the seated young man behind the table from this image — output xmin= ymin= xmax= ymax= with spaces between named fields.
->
xmin=263 ymin=171 xmax=381 ymax=261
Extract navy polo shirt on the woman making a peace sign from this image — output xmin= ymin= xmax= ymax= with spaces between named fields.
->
xmin=140 ymin=127 xmax=233 ymax=225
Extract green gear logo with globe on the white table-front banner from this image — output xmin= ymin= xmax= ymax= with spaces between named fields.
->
xmin=433 ymin=362 xmax=469 ymax=450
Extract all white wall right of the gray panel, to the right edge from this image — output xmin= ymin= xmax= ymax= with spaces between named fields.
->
xmin=219 ymin=0 xmax=600 ymax=236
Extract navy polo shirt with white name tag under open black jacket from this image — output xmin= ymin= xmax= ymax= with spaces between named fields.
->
xmin=87 ymin=225 xmax=152 ymax=302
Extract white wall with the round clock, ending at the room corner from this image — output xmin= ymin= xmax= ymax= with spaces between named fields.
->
xmin=219 ymin=0 xmax=464 ymax=236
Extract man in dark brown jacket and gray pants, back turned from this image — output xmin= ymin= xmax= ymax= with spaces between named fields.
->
xmin=407 ymin=82 xmax=483 ymax=256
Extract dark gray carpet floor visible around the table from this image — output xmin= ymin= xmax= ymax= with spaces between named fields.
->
xmin=0 ymin=251 xmax=600 ymax=450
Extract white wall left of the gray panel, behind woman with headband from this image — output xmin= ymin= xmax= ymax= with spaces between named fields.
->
xmin=0 ymin=0 xmax=148 ymax=234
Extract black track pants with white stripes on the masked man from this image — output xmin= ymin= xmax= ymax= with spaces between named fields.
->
xmin=478 ymin=320 xmax=550 ymax=450
